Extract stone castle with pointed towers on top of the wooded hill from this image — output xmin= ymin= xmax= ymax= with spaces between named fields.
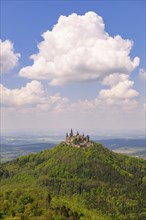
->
xmin=65 ymin=129 xmax=93 ymax=147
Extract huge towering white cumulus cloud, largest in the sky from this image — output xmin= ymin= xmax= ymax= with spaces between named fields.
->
xmin=19 ymin=12 xmax=139 ymax=85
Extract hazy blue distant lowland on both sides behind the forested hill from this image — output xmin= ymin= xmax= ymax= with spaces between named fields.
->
xmin=0 ymin=135 xmax=146 ymax=163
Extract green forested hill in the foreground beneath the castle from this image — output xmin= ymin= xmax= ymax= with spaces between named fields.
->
xmin=0 ymin=143 xmax=146 ymax=220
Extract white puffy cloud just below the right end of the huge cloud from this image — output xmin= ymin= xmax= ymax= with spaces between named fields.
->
xmin=73 ymin=74 xmax=139 ymax=111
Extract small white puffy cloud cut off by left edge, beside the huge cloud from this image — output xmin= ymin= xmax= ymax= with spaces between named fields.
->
xmin=0 ymin=40 xmax=20 ymax=73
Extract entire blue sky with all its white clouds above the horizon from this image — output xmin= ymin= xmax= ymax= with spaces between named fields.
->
xmin=0 ymin=0 xmax=146 ymax=135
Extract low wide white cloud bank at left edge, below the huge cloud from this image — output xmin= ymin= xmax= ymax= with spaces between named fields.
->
xmin=0 ymin=80 xmax=68 ymax=110
